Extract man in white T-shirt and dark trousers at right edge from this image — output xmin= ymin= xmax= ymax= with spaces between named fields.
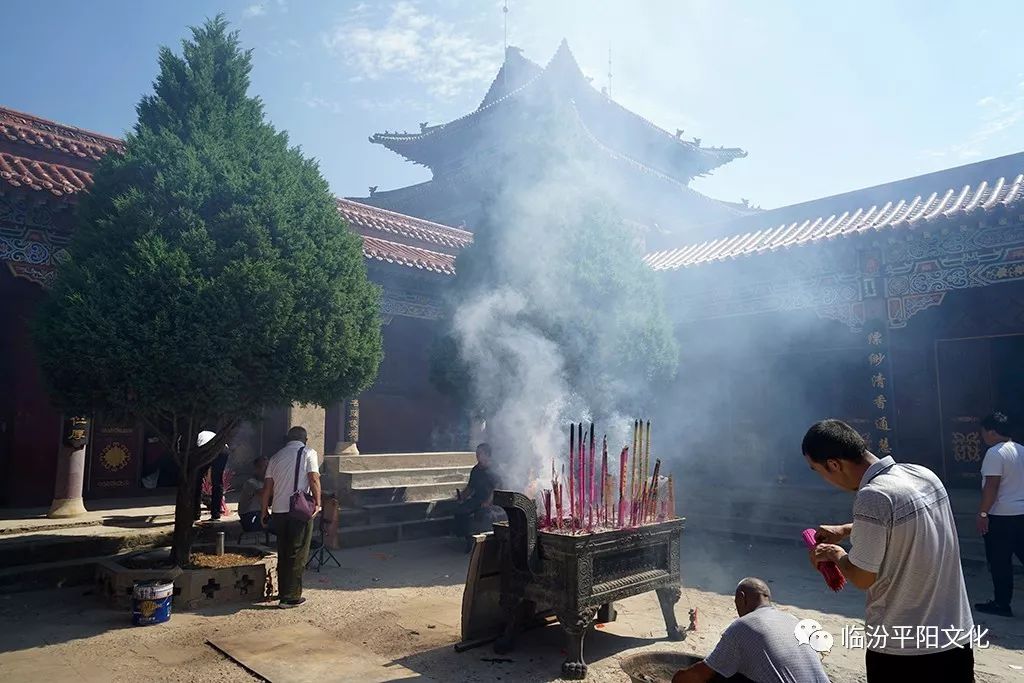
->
xmin=974 ymin=413 xmax=1024 ymax=616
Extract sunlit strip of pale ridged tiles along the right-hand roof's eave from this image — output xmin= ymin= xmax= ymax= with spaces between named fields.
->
xmin=644 ymin=154 xmax=1024 ymax=270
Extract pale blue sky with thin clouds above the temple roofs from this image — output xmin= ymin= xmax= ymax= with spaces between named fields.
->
xmin=0 ymin=0 xmax=1024 ymax=208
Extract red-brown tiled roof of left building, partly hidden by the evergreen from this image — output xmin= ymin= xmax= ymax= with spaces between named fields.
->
xmin=0 ymin=106 xmax=473 ymax=275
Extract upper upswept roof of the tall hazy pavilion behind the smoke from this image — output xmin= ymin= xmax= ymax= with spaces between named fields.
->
xmin=370 ymin=40 xmax=746 ymax=183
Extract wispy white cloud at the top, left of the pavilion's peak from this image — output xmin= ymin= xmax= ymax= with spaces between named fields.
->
xmin=323 ymin=0 xmax=502 ymax=98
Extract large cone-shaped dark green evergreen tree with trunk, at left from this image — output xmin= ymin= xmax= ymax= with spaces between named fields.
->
xmin=36 ymin=16 xmax=382 ymax=565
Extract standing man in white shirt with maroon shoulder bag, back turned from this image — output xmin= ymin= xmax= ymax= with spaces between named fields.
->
xmin=262 ymin=427 xmax=321 ymax=607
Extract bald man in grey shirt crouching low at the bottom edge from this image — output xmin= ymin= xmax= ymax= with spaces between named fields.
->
xmin=672 ymin=577 xmax=828 ymax=683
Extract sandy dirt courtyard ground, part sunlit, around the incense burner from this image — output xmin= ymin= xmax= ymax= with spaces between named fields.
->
xmin=0 ymin=536 xmax=1024 ymax=683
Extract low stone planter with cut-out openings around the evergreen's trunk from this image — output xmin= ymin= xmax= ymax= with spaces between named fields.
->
xmin=96 ymin=545 xmax=278 ymax=609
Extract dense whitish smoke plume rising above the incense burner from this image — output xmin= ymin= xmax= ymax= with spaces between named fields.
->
xmin=440 ymin=143 xmax=656 ymax=495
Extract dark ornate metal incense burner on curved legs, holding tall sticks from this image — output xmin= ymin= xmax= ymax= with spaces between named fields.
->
xmin=494 ymin=490 xmax=686 ymax=679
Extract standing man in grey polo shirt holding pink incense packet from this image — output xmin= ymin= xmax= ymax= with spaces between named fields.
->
xmin=803 ymin=420 xmax=974 ymax=683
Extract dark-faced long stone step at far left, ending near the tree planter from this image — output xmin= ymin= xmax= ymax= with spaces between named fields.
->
xmin=0 ymin=524 xmax=173 ymax=568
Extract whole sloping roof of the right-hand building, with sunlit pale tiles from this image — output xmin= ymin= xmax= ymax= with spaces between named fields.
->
xmin=644 ymin=153 xmax=1024 ymax=270
